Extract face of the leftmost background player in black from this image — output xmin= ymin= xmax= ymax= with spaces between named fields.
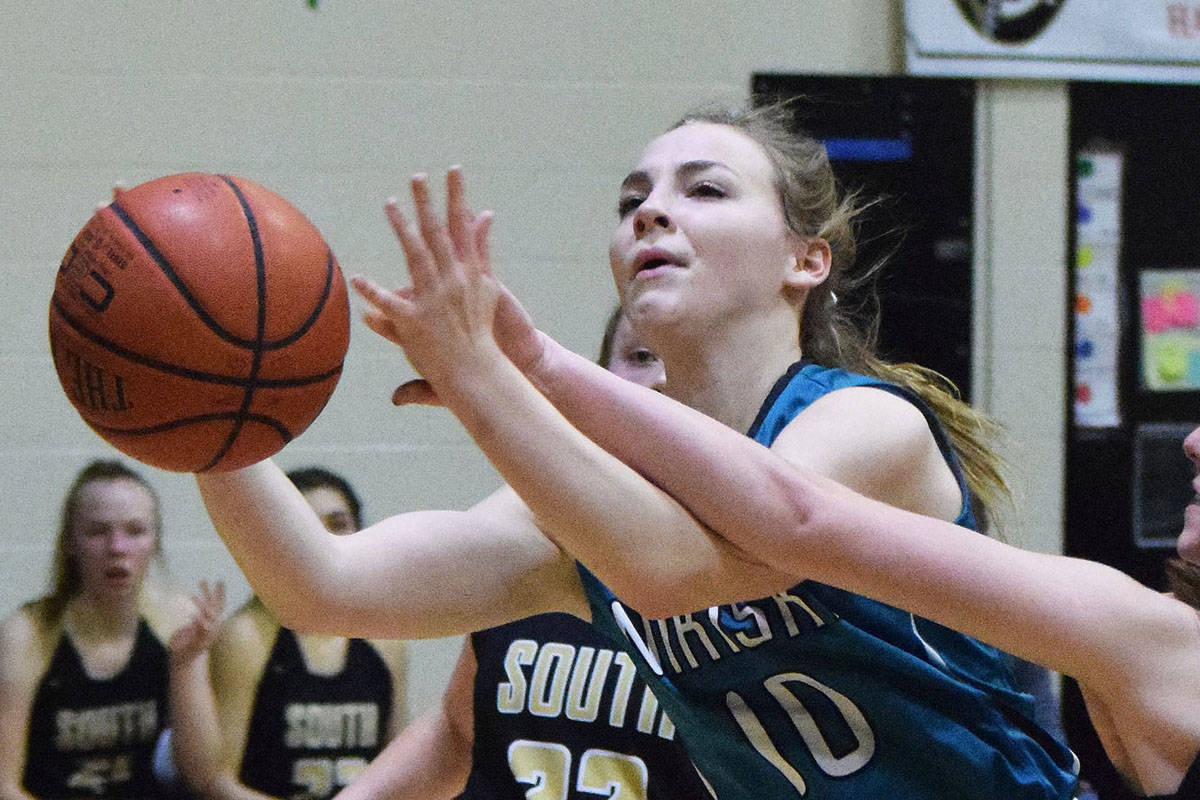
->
xmin=71 ymin=479 xmax=158 ymax=601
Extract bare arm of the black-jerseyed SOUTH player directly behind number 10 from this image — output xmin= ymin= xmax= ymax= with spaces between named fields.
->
xmin=336 ymin=643 xmax=475 ymax=800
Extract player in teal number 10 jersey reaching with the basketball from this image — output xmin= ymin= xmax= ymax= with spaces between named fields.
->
xmin=197 ymin=107 xmax=1075 ymax=800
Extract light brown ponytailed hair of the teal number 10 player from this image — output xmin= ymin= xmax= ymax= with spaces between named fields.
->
xmin=672 ymin=101 xmax=1009 ymax=532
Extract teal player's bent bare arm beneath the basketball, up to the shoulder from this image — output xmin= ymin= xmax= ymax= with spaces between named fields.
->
xmin=196 ymin=461 xmax=588 ymax=638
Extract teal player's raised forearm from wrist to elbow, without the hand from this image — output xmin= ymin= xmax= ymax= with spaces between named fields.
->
xmin=439 ymin=345 xmax=758 ymax=615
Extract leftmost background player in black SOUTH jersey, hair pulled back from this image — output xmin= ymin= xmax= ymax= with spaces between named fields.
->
xmin=0 ymin=461 xmax=194 ymax=800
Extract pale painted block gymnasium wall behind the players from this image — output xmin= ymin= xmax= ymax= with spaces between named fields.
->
xmin=0 ymin=0 xmax=1066 ymax=711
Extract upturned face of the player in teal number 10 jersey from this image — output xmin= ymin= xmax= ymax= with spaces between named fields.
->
xmin=608 ymin=122 xmax=796 ymax=335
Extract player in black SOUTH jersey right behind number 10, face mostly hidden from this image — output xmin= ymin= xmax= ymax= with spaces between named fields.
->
xmin=337 ymin=307 xmax=710 ymax=800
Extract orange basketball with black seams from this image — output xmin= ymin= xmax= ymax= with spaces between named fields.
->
xmin=49 ymin=173 xmax=349 ymax=473
